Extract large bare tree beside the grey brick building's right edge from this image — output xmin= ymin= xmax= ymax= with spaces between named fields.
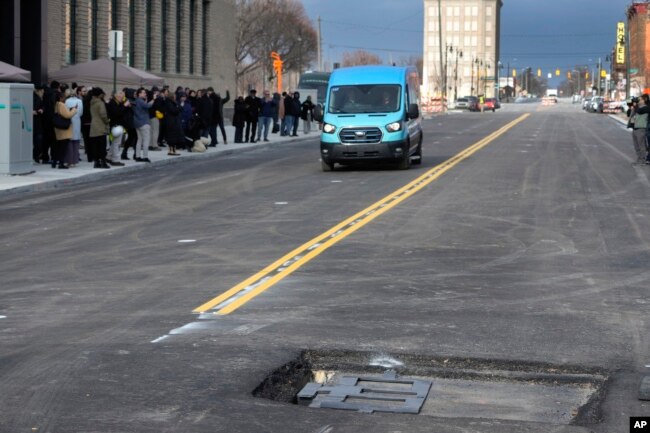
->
xmin=235 ymin=0 xmax=317 ymax=89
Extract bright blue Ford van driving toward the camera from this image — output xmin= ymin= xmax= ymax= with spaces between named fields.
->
xmin=317 ymin=66 xmax=422 ymax=171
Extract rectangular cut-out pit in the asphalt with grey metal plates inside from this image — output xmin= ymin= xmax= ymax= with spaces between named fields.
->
xmin=253 ymin=351 xmax=608 ymax=425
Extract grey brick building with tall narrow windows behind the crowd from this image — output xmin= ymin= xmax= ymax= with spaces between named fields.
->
xmin=0 ymin=0 xmax=236 ymax=91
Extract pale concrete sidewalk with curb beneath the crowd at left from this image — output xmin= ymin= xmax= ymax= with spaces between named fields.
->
xmin=0 ymin=124 xmax=320 ymax=196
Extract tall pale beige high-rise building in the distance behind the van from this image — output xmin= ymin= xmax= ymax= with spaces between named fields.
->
xmin=422 ymin=0 xmax=503 ymax=101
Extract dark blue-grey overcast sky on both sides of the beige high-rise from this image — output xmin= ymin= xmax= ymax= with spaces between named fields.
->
xmin=302 ymin=0 xmax=631 ymax=86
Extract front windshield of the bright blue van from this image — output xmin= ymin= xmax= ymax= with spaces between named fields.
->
xmin=329 ymin=84 xmax=401 ymax=114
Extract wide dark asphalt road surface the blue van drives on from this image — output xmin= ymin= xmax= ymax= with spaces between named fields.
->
xmin=0 ymin=101 xmax=650 ymax=433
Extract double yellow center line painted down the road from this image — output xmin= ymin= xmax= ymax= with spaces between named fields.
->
xmin=193 ymin=114 xmax=530 ymax=315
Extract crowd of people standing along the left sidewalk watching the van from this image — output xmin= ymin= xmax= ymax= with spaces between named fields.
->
xmin=33 ymin=81 xmax=315 ymax=169
